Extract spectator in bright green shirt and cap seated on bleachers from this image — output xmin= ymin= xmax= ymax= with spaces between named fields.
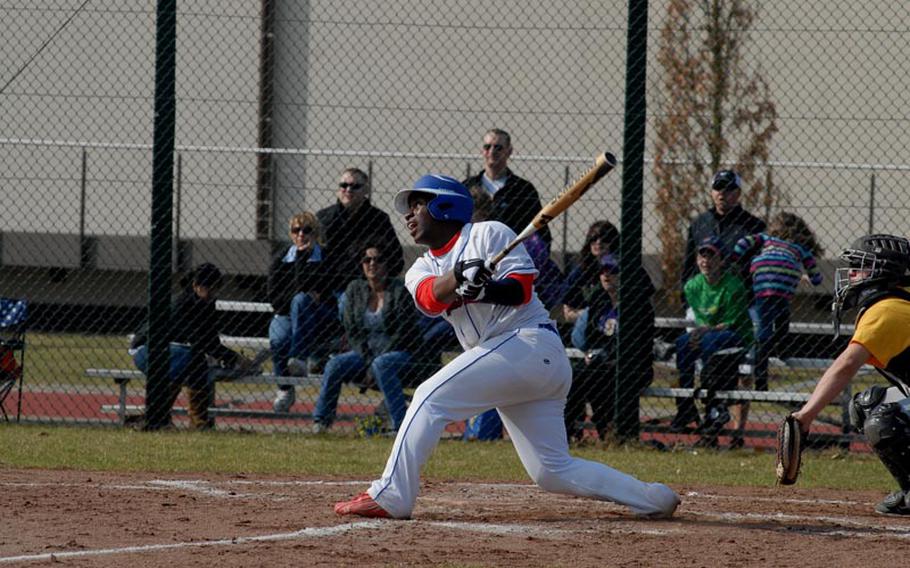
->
xmin=670 ymin=237 xmax=752 ymax=440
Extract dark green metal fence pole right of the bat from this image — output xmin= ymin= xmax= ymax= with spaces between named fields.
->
xmin=613 ymin=0 xmax=654 ymax=440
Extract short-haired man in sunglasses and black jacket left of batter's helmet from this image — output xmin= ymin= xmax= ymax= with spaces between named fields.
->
xmin=316 ymin=168 xmax=404 ymax=293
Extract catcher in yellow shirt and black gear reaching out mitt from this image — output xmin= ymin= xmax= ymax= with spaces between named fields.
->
xmin=777 ymin=235 xmax=910 ymax=515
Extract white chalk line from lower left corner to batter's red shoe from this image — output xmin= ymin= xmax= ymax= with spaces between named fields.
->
xmin=0 ymin=520 xmax=384 ymax=564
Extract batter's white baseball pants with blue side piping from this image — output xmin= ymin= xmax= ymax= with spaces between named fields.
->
xmin=368 ymin=324 xmax=677 ymax=518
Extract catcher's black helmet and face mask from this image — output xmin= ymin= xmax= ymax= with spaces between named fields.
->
xmin=831 ymin=235 xmax=910 ymax=337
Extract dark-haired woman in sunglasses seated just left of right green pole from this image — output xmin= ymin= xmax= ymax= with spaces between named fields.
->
xmin=562 ymin=221 xmax=619 ymax=351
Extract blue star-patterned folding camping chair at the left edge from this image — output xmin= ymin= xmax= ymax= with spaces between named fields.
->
xmin=0 ymin=298 xmax=28 ymax=422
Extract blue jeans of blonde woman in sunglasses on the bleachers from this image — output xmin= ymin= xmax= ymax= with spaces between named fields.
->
xmin=269 ymin=292 xmax=338 ymax=376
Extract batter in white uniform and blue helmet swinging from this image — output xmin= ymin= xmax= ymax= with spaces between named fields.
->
xmin=335 ymin=175 xmax=680 ymax=519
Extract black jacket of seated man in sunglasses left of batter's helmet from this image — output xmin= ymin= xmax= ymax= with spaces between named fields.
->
xmin=316 ymin=202 xmax=404 ymax=291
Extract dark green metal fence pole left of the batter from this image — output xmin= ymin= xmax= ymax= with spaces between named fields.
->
xmin=145 ymin=0 xmax=177 ymax=430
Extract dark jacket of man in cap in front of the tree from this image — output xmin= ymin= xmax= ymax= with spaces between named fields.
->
xmin=680 ymin=205 xmax=765 ymax=289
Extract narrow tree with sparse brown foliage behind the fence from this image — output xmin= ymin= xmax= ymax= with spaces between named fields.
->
xmin=654 ymin=0 xmax=783 ymax=303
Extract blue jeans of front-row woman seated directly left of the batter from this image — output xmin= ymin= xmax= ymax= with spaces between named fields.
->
xmin=313 ymin=351 xmax=411 ymax=430
